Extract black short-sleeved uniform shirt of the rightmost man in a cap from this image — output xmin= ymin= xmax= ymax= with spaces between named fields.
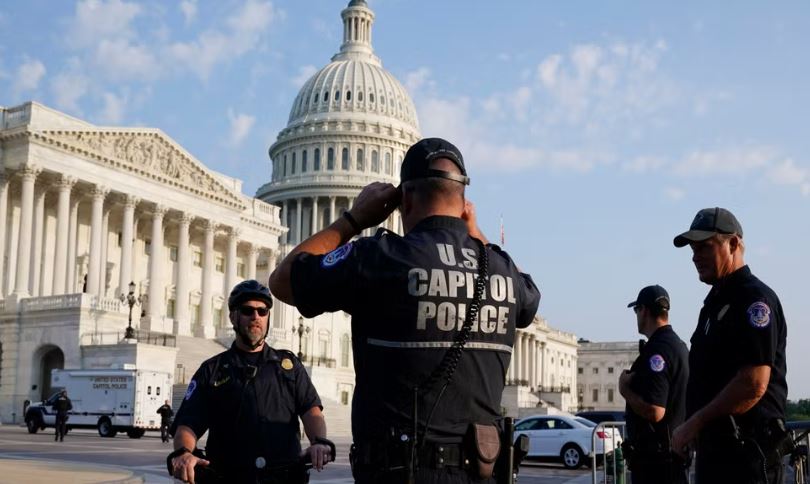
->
xmin=687 ymin=266 xmax=787 ymax=426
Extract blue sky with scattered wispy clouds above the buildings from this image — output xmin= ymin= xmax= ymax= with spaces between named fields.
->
xmin=0 ymin=0 xmax=810 ymax=399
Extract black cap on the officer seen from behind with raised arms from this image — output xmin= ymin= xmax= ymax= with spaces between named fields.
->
xmin=399 ymin=138 xmax=470 ymax=185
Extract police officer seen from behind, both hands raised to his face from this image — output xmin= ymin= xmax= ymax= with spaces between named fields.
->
xmin=270 ymin=138 xmax=540 ymax=483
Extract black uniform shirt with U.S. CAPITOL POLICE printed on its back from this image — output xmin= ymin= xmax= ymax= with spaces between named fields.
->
xmin=292 ymin=216 xmax=540 ymax=442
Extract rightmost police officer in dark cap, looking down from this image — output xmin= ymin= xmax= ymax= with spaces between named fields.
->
xmin=672 ymin=208 xmax=790 ymax=484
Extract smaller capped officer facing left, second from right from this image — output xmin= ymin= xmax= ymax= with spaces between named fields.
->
xmin=619 ymin=285 xmax=689 ymax=484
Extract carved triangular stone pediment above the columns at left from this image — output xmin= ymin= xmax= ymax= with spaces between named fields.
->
xmin=32 ymin=129 xmax=246 ymax=210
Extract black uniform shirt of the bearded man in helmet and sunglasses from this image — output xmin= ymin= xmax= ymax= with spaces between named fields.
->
xmin=172 ymin=344 xmax=321 ymax=472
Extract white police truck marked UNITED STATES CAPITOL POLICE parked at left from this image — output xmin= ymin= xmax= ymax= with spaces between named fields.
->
xmin=25 ymin=369 xmax=172 ymax=439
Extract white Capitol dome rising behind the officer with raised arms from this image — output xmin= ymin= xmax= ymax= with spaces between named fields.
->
xmin=256 ymin=0 xmax=421 ymax=244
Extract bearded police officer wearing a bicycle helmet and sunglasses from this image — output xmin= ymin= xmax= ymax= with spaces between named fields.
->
xmin=167 ymin=280 xmax=331 ymax=484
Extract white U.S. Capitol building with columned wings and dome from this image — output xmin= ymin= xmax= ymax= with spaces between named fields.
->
xmin=0 ymin=0 xmax=577 ymax=428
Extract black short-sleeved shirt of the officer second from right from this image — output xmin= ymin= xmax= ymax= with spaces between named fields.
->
xmin=626 ymin=324 xmax=689 ymax=451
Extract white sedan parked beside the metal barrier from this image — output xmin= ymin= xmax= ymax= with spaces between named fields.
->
xmin=515 ymin=414 xmax=621 ymax=469
